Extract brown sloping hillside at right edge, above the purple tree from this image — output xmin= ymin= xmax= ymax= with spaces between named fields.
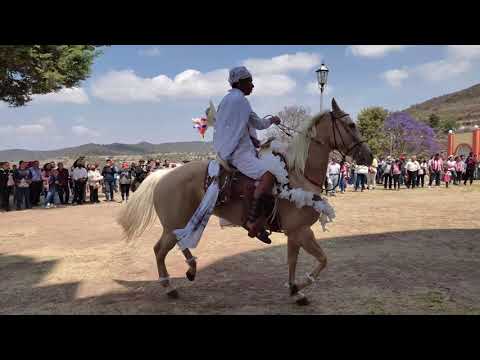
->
xmin=405 ymin=84 xmax=480 ymax=127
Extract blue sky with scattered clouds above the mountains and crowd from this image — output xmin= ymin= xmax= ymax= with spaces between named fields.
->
xmin=0 ymin=45 xmax=480 ymax=150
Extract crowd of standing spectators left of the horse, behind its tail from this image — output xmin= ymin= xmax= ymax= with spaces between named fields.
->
xmin=0 ymin=158 xmax=187 ymax=211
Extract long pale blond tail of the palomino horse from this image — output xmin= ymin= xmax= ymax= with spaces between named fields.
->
xmin=117 ymin=170 xmax=170 ymax=242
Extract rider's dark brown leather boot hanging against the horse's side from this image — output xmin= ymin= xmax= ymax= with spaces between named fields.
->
xmin=245 ymin=172 xmax=274 ymax=244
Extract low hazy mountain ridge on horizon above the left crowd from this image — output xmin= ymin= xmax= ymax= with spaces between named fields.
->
xmin=0 ymin=141 xmax=213 ymax=161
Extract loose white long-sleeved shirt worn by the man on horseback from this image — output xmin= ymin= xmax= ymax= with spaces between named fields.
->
xmin=213 ymin=89 xmax=271 ymax=161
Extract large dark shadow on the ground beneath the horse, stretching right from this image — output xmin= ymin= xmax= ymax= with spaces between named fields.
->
xmin=2 ymin=229 xmax=480 ymax=314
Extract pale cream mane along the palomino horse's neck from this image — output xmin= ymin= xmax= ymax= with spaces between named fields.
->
xmin=286 ymin=111 xmax=328 ymax=176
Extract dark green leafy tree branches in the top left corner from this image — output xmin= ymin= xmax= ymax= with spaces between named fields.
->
xmin=0 ymin=45 xmax=101 ymax=107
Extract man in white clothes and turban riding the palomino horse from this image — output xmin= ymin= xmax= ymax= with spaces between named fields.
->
xmin=213 ymin=66 xmax=280 ymax=244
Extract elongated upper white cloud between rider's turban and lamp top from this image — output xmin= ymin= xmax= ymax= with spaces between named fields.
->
xmin=243 ymin=52 xmax=321 ymax=75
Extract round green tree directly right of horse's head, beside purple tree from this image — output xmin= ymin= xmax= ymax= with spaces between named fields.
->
xmin=357 ymin=106 xmax=389 ymax=155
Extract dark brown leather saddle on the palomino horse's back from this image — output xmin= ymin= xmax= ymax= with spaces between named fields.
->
xmin=204 ymin=157 xmax=282 ymax=232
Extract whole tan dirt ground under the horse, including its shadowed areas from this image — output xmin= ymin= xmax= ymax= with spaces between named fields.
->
xmin=0 ymin=185 xmax=480 ymax=314
